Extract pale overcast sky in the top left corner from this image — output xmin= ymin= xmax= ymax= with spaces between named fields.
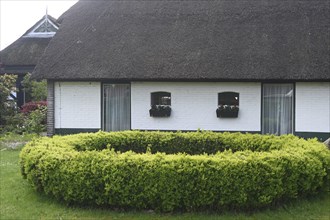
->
xmin=0 ymin=0 xmax=77 ymax=50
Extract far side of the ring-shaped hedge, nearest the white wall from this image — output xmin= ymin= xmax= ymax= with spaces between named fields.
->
xmin=73 ymin=131 xmax=318 ymax=155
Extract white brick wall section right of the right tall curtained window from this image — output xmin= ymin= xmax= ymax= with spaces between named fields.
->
xmin=296 ymin=82 xmax=330 ymax=132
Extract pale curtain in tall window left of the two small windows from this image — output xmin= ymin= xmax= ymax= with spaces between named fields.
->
xmin=103 ymin=84 xmax=131 ymax=131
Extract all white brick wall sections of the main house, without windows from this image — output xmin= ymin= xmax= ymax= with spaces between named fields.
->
xmin=51 ymin=82 xmax=330 ymax=132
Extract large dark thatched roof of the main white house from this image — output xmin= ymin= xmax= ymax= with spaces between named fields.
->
xmin=35 ymin=0 xmax=330 ymax=81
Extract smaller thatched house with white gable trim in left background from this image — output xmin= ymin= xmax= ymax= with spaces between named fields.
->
xmin=0 ymin=13 xmax=59 ymax=106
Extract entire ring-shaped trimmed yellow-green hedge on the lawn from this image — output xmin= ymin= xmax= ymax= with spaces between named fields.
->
xmin=20 ymin=131 xmax=330 ymax=212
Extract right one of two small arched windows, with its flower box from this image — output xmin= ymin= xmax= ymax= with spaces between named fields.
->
xmin=216 ymin=92 xmax=239 ymax=118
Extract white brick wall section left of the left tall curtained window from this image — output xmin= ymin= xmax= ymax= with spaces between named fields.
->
xmin=54 ymin=82 xmax=101 ymax=129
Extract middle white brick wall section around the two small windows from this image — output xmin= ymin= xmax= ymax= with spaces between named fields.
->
xmin=131 ymin=82 xmax=261 ymax=131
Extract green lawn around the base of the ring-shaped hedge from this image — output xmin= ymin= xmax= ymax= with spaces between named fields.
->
xmin=0 ymin=142 xmax=330 ymax=220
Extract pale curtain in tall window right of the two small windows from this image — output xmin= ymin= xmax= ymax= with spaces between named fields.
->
xmin=262 ymin=84 xmax=293 ymax=135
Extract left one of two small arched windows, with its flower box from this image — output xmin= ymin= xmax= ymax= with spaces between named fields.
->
xmin=149 ymin=92 xmax=171 ymax=117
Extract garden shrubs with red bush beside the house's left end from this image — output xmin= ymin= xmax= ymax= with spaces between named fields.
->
xmin=0 ymin=73 xmax=47 ymax=134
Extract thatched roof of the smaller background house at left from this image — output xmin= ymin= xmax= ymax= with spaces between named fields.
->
xmin=0 ymin=15 xmax=59 ymax=72
